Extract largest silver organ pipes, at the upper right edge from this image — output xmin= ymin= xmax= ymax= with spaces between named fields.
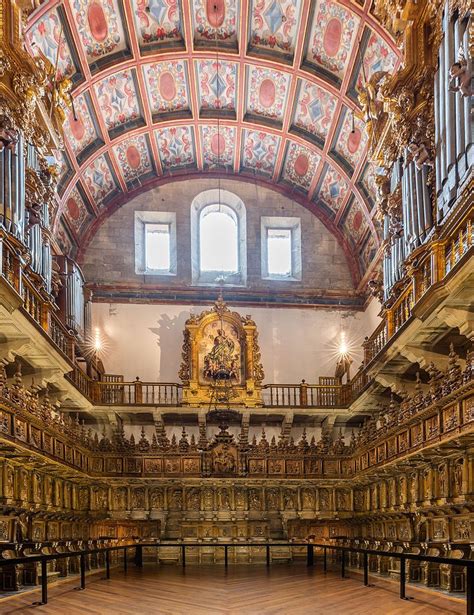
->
xmin=434 ymin=5 xmax=474 ymax=222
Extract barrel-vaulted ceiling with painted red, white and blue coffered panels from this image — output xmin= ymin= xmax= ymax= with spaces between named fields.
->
xmin=26 ymin=0 xmax=400 ymax=284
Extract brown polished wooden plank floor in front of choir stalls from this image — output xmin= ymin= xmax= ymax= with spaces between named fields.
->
xmin=0 ymin=564 xmax=466 ymax=615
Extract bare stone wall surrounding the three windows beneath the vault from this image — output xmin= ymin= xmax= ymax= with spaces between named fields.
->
xmin=80 ymin=178 xmax=354 ymax=294
